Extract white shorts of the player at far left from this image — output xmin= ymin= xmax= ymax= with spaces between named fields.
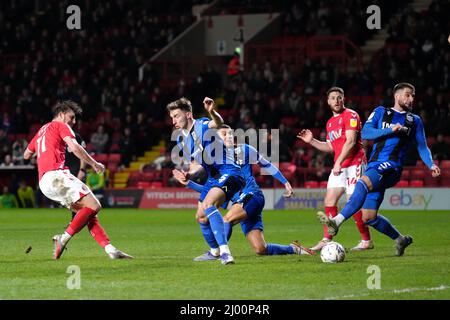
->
xmin=39 ymin=170 xmax=92 ymax=208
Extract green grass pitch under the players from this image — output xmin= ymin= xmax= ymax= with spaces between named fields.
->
xmin=0 ymin=209 xmax=450 ymax=300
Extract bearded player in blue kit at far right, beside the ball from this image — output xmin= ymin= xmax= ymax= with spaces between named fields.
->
xmin=317 ymin=83 xmax=441 ymax=256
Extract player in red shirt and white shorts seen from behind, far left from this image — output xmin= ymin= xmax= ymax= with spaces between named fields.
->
xmin=24 ymin=101 xmax=133 ymax=259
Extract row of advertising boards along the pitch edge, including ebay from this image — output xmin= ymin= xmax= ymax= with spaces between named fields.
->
xmin=104 ymin=188 xmax=450 ymax=211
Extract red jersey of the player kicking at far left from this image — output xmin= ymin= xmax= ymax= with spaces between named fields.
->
xmin=28 ymin=121 xmax=75 ymax=180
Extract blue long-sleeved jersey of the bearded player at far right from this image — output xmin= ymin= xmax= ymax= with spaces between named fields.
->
xmin=361 ymin=106 xmax=433 ymax=168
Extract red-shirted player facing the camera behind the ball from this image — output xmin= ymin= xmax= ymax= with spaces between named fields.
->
xmin=297 ymin=87 xmax=373 ymax=251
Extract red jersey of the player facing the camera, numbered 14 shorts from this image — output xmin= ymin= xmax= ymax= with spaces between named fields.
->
xmin=327 ymin=108 xmax=367 ymax=168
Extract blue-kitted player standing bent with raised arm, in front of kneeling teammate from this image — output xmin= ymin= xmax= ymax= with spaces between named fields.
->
xmin=167 ymin=97 xmax=245 ymax=265
